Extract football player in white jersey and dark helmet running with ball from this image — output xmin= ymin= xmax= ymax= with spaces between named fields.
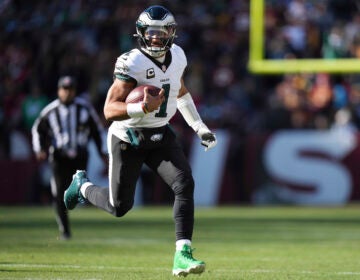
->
xmin=64 ymin=6 xmax=217 ymax=276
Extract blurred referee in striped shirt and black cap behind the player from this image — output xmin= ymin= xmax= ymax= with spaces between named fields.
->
xmin=32 ymin=76 xmax=107 ymax=240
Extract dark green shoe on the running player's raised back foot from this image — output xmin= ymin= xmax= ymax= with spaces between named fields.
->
xmin=64 ymin=170 xmax=89 ymax=210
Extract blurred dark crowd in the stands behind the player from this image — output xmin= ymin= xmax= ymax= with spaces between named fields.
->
xmin=0 ymin=0 xmax=360 ymax=159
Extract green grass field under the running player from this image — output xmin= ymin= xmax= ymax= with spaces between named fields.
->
xmin=0 ymin=205 xmax=360 ymax=280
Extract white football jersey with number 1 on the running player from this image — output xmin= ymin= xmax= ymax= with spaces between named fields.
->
xmin=110 ymin=44 xmax=187 ymax=142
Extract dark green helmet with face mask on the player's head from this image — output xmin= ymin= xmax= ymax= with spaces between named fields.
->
xmin=135 ymin=6 xmax=176 ymax=58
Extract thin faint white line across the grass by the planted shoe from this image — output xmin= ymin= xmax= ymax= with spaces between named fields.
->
xmin=0 ymin=263 xmax=360 ymax=275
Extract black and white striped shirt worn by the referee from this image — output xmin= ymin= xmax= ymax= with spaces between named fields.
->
xmin=32 ymin=97 xmax=104 ymax=157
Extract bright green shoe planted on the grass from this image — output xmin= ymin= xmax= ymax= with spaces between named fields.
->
xmin=173 ymin=245 xmax=205 ymax=277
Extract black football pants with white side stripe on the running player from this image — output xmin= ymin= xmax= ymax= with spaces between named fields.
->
xmin=86 ymin=129 xmax=194 ymax=240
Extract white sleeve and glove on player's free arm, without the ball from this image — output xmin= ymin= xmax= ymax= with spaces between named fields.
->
xmin=177 ymin=93 xmax=217 ymax=151
